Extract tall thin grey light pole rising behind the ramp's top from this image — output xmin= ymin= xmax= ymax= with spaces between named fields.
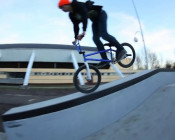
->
xmin=131 ymin=0 xmax=148 ymax=69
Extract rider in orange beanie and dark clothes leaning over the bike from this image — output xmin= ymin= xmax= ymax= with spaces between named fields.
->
xmin=58 ymin=0 xmax=126 ymax=65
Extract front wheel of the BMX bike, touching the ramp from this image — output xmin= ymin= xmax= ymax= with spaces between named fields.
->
xmin=73 ymin=65 xmax=101 ymax=93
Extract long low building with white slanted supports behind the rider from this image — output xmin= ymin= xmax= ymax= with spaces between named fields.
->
xmin=0 ymin=44 xmax=136 ymax=85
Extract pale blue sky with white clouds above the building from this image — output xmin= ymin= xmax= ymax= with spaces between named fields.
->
xmin=0 ymin=0 xmax=175 ymax=60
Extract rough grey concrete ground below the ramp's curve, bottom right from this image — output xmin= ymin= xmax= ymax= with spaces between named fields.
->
xmin=84 ymin=84 xmax=175 ymax=140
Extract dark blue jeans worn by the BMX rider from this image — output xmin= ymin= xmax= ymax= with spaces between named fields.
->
xmin=92 ymin=11 xmax=123 ymax=59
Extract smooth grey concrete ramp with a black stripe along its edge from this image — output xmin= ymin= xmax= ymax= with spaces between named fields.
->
xmin=2 ymin=69 xmax=175 ymax=140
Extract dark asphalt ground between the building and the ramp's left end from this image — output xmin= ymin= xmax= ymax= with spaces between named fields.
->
xmin=0 ymin=85 xmax=77 ymax=132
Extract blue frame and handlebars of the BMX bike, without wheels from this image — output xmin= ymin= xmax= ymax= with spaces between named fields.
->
xmin=74 ymin=42 xmax=115 ymax=62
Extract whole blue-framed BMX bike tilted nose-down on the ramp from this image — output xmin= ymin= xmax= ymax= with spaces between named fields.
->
xmin=73 ymin=42 xmax=136 ymax=93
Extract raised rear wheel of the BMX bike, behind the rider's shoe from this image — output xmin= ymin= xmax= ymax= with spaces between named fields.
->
xmin=118 ymin=43 xmax=136 ymax=68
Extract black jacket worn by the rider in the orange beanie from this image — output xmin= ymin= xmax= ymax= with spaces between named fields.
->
xmin=69 ymin=0 xmax=102 ymax=38
